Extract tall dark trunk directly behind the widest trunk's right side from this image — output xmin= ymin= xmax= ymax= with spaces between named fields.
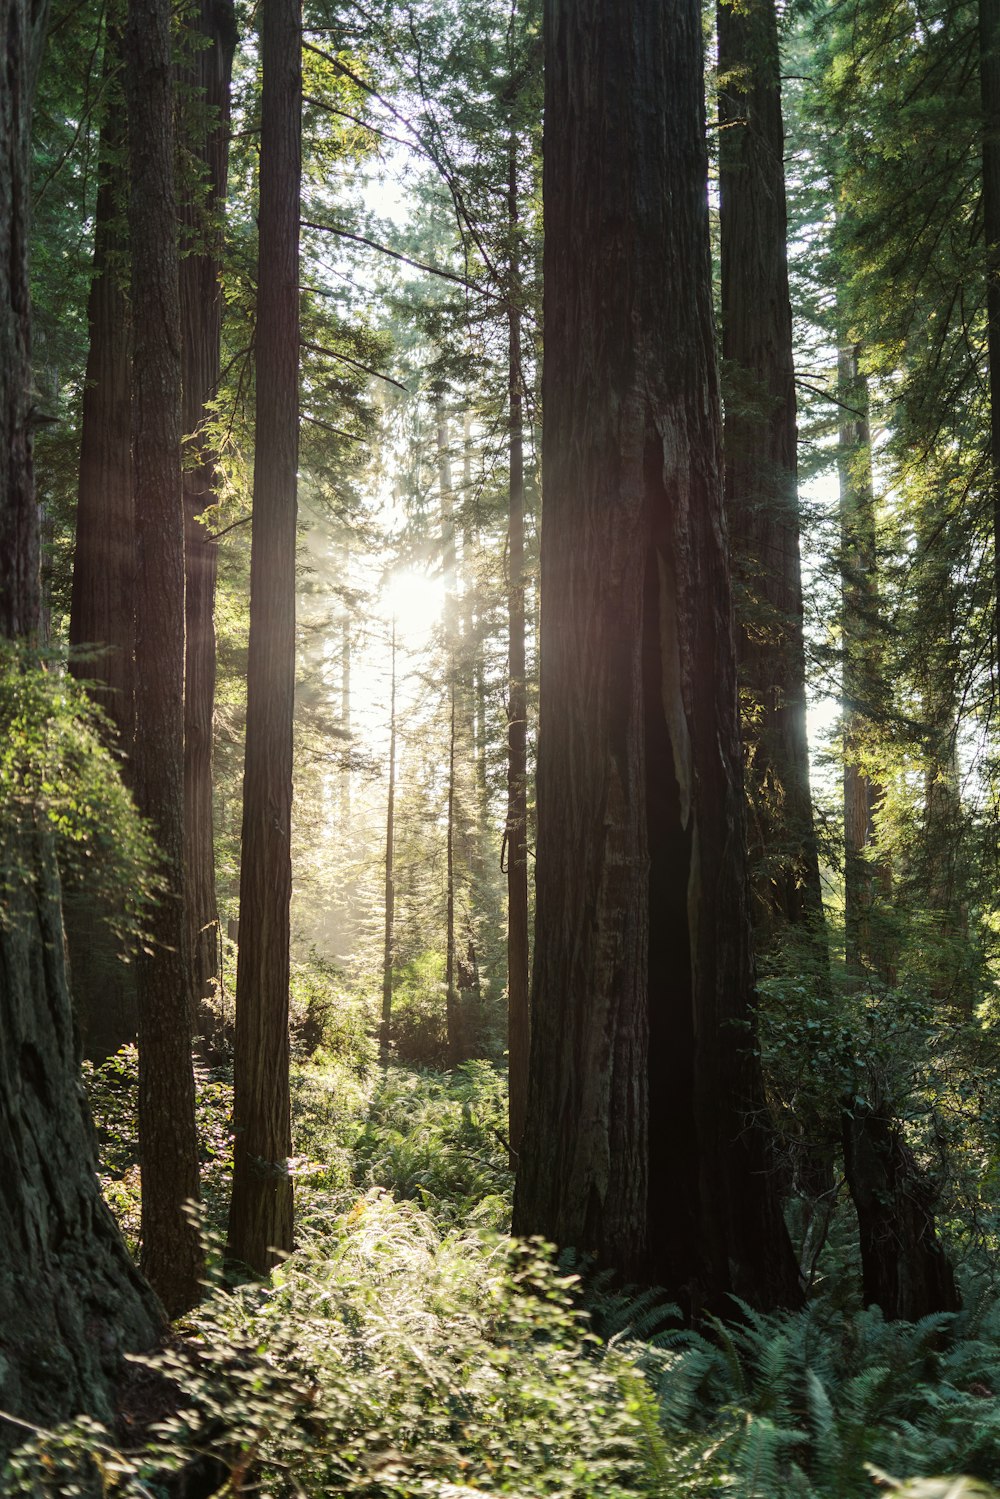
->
xmin=718 ymin=0 xmax=825 ymax=941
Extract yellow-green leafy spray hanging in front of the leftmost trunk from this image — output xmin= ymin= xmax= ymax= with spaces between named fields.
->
xmin=0 ymin=642 xmax=159 ymax=946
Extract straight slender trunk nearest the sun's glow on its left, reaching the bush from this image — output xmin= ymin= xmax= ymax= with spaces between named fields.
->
xmin=229 ymin=0 xmax=301 ymax=1274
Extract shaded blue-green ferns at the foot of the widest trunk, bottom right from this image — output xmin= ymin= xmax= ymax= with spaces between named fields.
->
xmin=658 ymin=1300 xmax=1000 ymax=1499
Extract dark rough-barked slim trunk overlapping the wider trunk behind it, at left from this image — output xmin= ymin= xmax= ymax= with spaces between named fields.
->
xmin=124 ymin=0 xmax=202 ymax=1316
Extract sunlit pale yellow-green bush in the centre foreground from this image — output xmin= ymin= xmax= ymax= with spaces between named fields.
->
xmin=3 ymin=1192 xmax=720 ymax=1499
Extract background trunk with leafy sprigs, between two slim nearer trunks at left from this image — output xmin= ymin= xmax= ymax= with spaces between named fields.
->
xmin=180 ymin=0 xmax=237 ymax=1030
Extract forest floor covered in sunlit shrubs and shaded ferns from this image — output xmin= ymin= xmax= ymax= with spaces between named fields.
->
xmin=3 ymin=1051 xmax=1000 ymax=1499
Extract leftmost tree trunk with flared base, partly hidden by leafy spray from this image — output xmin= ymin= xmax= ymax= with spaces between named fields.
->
xmin=0 ymin=0 xmax=162 ymax=1457
